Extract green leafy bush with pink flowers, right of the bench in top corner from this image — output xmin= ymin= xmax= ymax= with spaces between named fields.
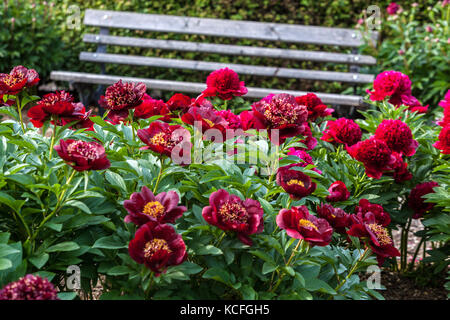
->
xmin=366 ymin=1 xmax=450 ymax=109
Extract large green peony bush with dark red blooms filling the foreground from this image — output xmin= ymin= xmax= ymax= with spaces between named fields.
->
xmin=0 ymin=63 xmax=448 ymax=300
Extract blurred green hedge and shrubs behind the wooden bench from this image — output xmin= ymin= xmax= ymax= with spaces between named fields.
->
xmin=0 ymin=0 xmax=449 ymax=103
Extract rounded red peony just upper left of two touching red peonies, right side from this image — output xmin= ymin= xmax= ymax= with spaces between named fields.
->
xmin=320 ymin=118 xmax=362 ymax=146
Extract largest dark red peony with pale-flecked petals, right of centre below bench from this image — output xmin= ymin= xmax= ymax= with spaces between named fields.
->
xmin=251 ymin=93 xmax=308 ymax=144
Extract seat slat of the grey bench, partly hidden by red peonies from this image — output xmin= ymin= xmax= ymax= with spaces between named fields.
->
xmin=50 ymin=71 xmax=364 ymax=107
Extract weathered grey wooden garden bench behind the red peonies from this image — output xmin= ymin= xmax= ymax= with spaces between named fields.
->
xmin=50 ymin=9 xmax=378 ymax=109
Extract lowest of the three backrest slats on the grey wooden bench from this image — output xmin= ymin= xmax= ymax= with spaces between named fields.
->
xmin=80 ymin=52 xmax=374 ymax=83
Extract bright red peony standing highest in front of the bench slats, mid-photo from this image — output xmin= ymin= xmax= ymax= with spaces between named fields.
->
xmin=202 ymin=68 xmax=248 ymax=100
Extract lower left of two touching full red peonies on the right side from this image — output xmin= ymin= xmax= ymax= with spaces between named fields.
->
xmin=346 ymin=136 xmax=396 ymax=179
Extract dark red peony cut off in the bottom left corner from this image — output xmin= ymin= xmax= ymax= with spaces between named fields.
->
xmin=0 ymin=274 xmax=59 ymax=300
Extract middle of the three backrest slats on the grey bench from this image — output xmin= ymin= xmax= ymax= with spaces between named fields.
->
xmin=83 ymin=34 xmax=377 ymax=65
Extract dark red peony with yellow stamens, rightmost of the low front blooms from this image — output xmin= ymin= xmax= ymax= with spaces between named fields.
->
xmin=347 ymin=213 xmax=400 ymax=266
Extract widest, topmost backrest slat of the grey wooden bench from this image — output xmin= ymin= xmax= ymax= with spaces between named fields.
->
xmin=84 ymin=9 xmax=378 ymax=47
